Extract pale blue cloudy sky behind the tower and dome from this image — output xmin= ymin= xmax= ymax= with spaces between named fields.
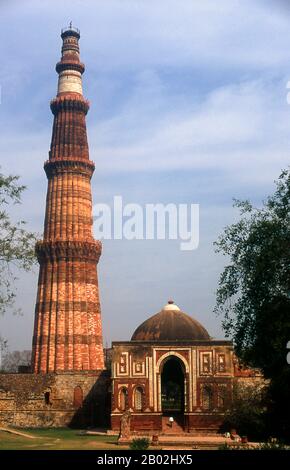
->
xmin=0 ymin=0 xmax=290 ymax=349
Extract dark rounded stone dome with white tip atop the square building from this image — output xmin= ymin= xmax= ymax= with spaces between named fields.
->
xmin=131 ymin=300 xmax=210 ymax=341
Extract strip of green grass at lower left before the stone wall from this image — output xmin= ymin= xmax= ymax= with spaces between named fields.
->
xmin=0 ymin=428 xmax=118 ymax=450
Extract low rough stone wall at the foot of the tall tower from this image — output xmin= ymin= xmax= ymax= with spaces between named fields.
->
xmin=0 ymin=371 xmax=110 ymax=428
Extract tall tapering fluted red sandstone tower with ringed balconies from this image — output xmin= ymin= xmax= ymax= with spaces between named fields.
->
xmin=32 ymin=27 xmax=104 ymax=373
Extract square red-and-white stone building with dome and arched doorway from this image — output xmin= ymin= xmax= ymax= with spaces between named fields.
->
xmin=111 ymin=301 xmax=259 ymax=434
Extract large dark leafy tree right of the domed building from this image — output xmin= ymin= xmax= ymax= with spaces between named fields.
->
xmin=215 ymin=170 xmax=290 ymax=438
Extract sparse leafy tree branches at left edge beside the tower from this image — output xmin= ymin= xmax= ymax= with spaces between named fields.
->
xmin=0 ymin=167 xmax=36 ymax=314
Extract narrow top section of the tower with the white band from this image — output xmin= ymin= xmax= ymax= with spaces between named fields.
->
xmin=56 ymin=23 xmax=85 ymax=96
